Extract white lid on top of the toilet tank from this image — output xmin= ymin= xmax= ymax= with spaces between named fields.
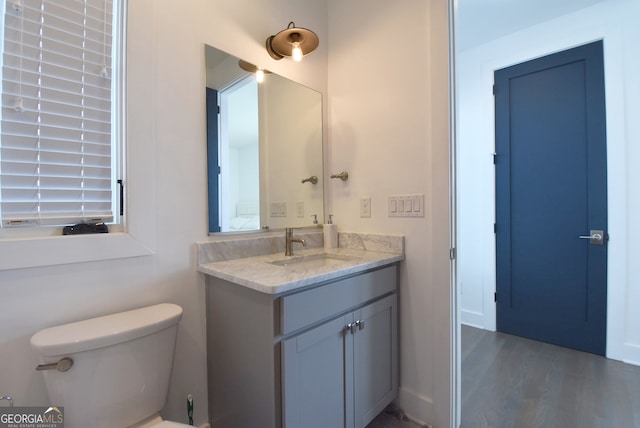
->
xmin=31 ymin=303 xmax=182 ymax=356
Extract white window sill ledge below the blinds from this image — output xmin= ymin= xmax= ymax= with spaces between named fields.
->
xmin=0 ymin=232 xmax=153 ymax=271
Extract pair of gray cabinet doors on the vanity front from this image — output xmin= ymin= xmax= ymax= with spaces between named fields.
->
xmin=282 ymin=294 xmax=397 ymax=428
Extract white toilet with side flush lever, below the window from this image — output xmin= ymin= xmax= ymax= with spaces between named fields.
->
xmin=31 ymin=303 xmax=189 ymax=428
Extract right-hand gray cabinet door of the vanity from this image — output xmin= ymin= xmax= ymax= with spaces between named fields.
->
xmin=348 ymin=294 xmax=398 ymax=428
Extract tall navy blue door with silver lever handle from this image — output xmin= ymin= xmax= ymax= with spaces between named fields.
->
xmin=494 ymin=42 xmax=607 ymax=355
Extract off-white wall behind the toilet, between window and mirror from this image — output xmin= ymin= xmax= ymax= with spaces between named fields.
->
xmin=0 ymin=0 xmax=327 ymax=424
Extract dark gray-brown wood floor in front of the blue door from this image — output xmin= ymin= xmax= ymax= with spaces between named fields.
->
xmin=461 ymin=326 xmax=640 ymax=428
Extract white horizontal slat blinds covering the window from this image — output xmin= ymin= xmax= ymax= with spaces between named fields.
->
xmin=0 ymin=0 xmax=115 ymax=227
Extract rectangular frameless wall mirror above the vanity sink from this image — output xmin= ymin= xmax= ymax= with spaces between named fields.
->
xmin=205 ymin=45 xmax=324 ymax=233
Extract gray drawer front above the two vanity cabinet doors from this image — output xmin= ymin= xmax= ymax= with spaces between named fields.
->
xmin=280 ymin=265 xmax=397 ymax=335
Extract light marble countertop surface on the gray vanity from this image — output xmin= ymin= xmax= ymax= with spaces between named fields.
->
xmin=198 ymin=248 xmax=404 ymax=294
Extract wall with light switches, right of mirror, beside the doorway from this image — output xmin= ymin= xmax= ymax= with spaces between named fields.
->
xmin=328 ymin=0 xmax=451 ymax=427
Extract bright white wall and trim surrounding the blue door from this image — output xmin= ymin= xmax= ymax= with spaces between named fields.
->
xmin=457 ymin=0 xmax=640 ymax=364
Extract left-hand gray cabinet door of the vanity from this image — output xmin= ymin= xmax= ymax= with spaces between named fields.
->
xmin=281 ymin=315 xmax=351 ymax=428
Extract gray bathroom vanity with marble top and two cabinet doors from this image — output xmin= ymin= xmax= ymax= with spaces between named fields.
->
xmin=199 ymin=237 xmax=404 ymax=428
